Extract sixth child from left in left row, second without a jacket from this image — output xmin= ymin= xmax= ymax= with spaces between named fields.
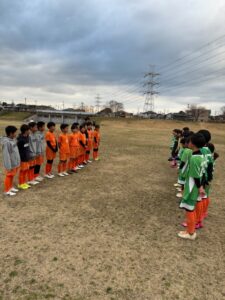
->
xmin=58 ymin=124 xmax=70 ymax=177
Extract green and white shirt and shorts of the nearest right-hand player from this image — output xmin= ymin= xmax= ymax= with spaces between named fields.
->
xmin=180 ymin=151 xmax=205 ymax=211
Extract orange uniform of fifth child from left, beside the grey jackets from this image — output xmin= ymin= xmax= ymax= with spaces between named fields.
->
xmin=45 ymin=131 xmax=57 ymax=174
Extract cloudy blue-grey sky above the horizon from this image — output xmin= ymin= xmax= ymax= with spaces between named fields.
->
xmin=0 ymin=0 xmax=225 ymax=113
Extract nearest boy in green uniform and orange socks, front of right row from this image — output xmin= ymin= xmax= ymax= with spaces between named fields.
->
xmin=178 ymin=133 xmax=205 ymax=240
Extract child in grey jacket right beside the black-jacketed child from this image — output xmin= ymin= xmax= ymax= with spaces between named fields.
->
xmin=28 ymin=122 xmax=39 ymax=185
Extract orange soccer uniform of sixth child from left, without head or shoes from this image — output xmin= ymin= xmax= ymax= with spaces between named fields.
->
xmin=58 ymin=133 xmax=70 ymax=173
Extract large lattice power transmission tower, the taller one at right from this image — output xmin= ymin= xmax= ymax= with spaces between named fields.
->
xmin=144 ymin=69 xmax=160 ymax=112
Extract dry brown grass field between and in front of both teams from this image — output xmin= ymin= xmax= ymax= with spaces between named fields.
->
xmin=0 ymin=120 xmax=225 ymax=300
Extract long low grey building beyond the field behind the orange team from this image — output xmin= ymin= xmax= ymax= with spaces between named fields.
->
xmin=27 ymin=110 xmax=95 ymax=124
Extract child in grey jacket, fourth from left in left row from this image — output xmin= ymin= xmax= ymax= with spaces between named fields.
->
xmin=34 ymin=121 xmax=45 ymax=182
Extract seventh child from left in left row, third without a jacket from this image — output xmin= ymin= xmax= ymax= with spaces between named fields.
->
xmin=69 ymin=123 xmax=79 ymax=173
